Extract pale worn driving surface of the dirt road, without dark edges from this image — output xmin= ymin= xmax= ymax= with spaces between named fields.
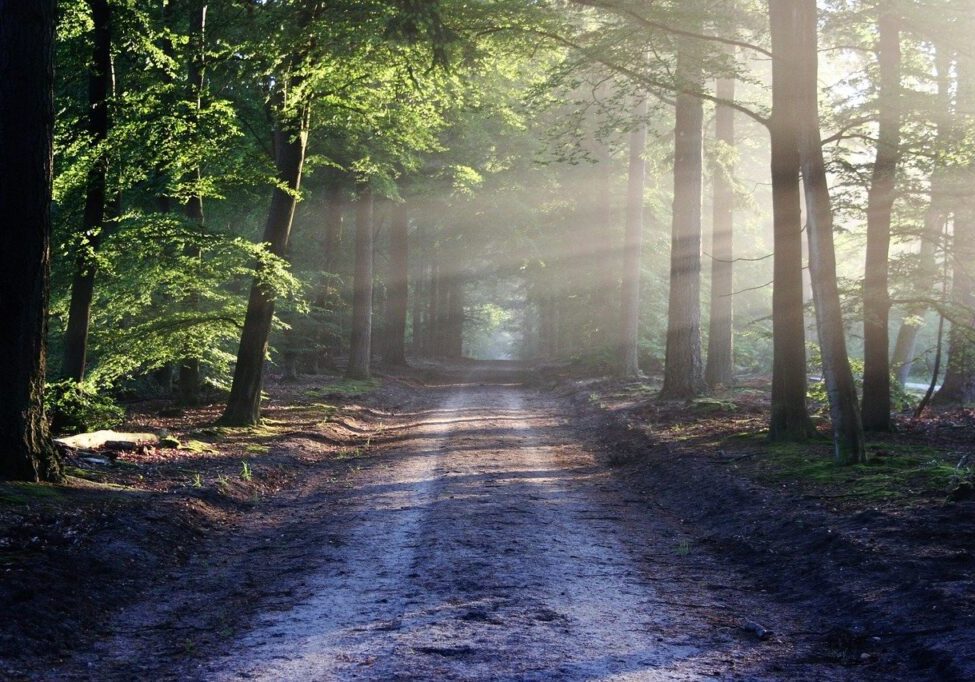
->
xmin=195 ymin=378 xmax=860 ymax=680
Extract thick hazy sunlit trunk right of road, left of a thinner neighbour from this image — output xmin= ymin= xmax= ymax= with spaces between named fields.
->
xmin=660 ymin=35 xmax=707 ymax=399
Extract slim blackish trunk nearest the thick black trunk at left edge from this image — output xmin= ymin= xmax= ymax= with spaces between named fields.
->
xmin=62 ymin=0 xmax=112 ymax=381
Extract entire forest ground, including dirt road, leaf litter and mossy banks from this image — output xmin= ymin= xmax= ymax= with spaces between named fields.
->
xmin=0 ymin=363 xmax=975 ymax=680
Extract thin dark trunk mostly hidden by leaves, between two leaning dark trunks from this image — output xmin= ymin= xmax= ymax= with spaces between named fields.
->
xmin=179 ymin=2 xmax=207 ymax=405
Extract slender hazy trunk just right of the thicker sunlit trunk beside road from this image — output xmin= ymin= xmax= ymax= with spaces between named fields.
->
xmin=704 ymin=70 xmax=735 ymax=386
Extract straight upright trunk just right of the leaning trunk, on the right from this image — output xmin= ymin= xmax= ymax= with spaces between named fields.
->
xmin=862 ymin=14 xmax=901 ymax=431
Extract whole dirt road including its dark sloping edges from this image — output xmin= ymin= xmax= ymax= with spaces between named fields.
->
xmin=49 ymin=370 xmax=867 ymax=680
